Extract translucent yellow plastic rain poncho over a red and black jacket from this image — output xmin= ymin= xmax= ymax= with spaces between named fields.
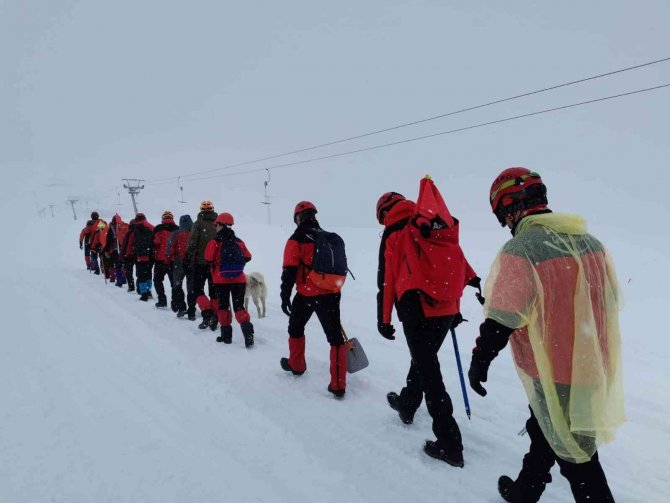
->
xmin=484 ymin=213 xmax=625 ymax=463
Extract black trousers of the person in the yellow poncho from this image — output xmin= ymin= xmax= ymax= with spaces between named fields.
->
xmin=514 ymin=410 xmax=614 ymax=503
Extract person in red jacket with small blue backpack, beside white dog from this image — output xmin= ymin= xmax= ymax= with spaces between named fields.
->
xmin=205 ymin=213 xmax=254 ymax=348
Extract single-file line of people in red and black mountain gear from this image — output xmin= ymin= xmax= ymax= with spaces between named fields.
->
xmin=80 ymin=167 xmax=625 ymax=503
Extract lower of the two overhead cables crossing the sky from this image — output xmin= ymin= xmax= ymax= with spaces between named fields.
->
xmin=147 ymin=84 xmax=670 ymax=185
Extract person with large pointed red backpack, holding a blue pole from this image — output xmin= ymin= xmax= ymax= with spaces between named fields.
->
xmin=377 ymin=181 xmax=476 ymax=467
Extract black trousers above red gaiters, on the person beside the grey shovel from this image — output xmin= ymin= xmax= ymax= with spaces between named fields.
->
xmin=288 ymin=293 xmax=344 ymax=346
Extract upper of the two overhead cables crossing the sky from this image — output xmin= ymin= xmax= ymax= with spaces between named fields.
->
xmin=147 ymin=57 xmax=670 ymax=185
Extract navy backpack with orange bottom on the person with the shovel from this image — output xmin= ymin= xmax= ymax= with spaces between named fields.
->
xmin=309 ymin=229 xmax=349 ymax=292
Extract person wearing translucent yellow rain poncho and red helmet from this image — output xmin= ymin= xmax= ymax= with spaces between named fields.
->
xmin=468 ymin=168 xmax=625 ymax=503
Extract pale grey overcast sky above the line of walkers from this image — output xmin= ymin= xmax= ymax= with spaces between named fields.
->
xmin=0 ymin=0 xmax=670 ymax=232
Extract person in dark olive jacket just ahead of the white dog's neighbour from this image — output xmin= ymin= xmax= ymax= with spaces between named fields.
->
xmin=184 ymin=200 xmax=219 ymax=331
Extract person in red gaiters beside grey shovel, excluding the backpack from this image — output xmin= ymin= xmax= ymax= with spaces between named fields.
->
xmin=280 ymin=201 xmax=347 ymax=398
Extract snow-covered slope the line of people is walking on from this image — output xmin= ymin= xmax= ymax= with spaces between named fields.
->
xmin=0 ymin=212 xmax=670 ymax=503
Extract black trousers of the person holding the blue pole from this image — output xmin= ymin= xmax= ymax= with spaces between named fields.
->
xmin=401 ymin=316 xmax=463 ymax=451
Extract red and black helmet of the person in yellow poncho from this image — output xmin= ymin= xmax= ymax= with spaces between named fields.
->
xmin=489 ymin=167 xmax=547 ymax=227
